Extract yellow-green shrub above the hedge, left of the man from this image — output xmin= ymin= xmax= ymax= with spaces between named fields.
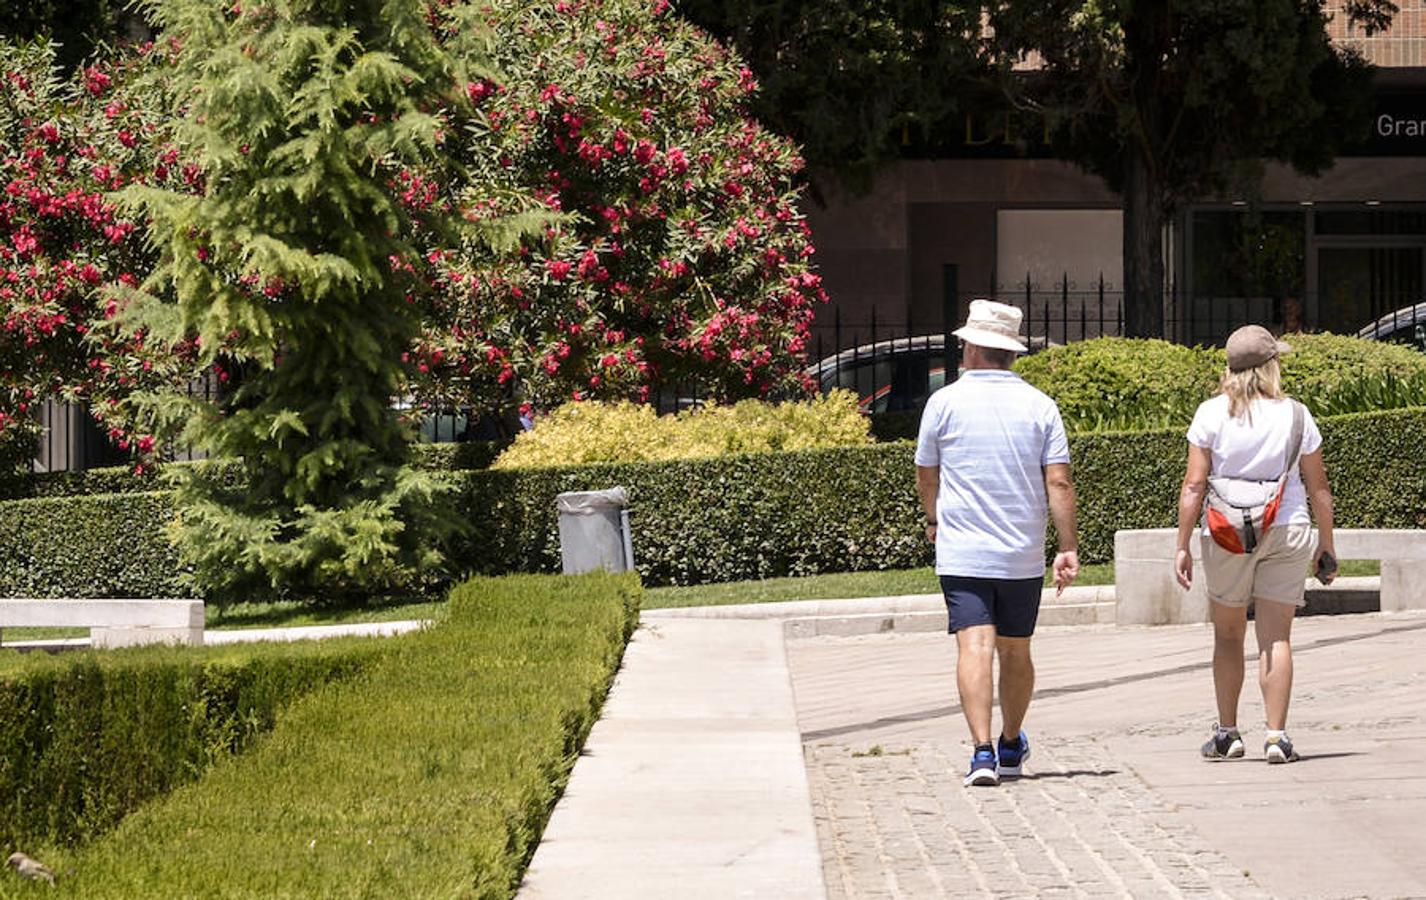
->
xmin=492 ymin=391 xmax=871 ymax=469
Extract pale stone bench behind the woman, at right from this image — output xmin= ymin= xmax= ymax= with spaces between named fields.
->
xmin=1114 ymin=528 xmax=1426 ymax=625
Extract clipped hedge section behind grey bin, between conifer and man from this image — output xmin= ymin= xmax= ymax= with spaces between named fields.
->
xmin=451 ymin=445 xmax=930 ymax=585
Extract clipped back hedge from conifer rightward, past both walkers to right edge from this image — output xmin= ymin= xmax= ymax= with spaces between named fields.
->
xmin=452 ymin=409 xmax=1426 ymax=586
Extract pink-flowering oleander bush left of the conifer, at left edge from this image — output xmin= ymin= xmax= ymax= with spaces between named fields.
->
xmin=0 ymin=41 xmax=197 ymax=471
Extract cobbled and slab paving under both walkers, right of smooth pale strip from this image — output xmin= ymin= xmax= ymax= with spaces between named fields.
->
xmin=789 ymin=616 xmax=1426 ymax=899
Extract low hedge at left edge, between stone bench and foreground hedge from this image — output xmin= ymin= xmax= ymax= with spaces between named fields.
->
xmin=0 ymin=639 xmax=379 ymax=847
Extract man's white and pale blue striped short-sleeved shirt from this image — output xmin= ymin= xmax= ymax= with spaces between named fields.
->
xmin=915 ymin=369 xmax=1070 ymax=579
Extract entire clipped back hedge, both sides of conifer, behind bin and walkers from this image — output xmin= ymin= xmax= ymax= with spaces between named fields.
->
xmin=0 ymin=409 xmax=1426 ymax=596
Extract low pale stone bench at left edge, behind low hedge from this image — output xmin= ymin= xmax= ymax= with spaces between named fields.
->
xmin=0 ymin=599 xmax=204 ymax=648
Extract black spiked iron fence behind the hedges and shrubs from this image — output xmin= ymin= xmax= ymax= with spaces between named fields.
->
xmin=31 ymin=285 xmax=1426 ymax=471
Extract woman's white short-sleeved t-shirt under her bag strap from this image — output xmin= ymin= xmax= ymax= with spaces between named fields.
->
xmin=1188 ymin=394 xmax=1322 ymax=525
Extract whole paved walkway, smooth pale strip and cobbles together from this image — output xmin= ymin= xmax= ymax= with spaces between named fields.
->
xmin=522 ymin=599 xmax=1426 ymax=899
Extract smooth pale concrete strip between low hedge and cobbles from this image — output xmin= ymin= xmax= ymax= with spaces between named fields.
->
xmin=520 ymin=619 xmax=826 ymax=900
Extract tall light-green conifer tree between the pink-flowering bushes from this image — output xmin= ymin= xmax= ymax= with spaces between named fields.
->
xmin=123 ymin=0 xmax=490 ymax=600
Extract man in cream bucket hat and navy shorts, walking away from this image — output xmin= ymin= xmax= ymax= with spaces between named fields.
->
xmin=915 ymin=300 xmax=1079 ymax=786
